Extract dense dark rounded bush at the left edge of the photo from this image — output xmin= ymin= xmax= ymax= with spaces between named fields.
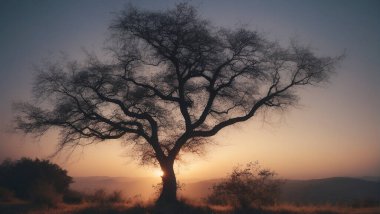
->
xmin=0 ymin=158 xmax=72 ymax=205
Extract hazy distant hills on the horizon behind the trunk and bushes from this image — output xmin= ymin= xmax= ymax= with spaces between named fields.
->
xmin=71 ymin=177 xmax=380 ymax=204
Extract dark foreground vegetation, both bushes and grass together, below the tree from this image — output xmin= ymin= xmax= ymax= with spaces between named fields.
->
xmin=0 ymin=158 xmax=380 ymax=214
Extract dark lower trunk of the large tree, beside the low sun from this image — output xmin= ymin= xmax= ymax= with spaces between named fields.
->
xmin=157 ymin=161 xmax=178 ymax=204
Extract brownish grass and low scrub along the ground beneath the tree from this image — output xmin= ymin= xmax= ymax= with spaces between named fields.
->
xmin=0 ymin=189 xmax=380 ymax=214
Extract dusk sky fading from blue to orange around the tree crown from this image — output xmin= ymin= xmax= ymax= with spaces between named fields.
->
xmin=0 ymin=0 xmax=380 ymax=179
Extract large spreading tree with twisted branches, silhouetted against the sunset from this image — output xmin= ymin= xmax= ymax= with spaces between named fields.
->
xmin=16 ymin=4 xmax=338 ymax=202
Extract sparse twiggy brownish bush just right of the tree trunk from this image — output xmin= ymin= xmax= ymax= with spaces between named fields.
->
xmin=207 ymin=162 xmax=282 ymax=210
